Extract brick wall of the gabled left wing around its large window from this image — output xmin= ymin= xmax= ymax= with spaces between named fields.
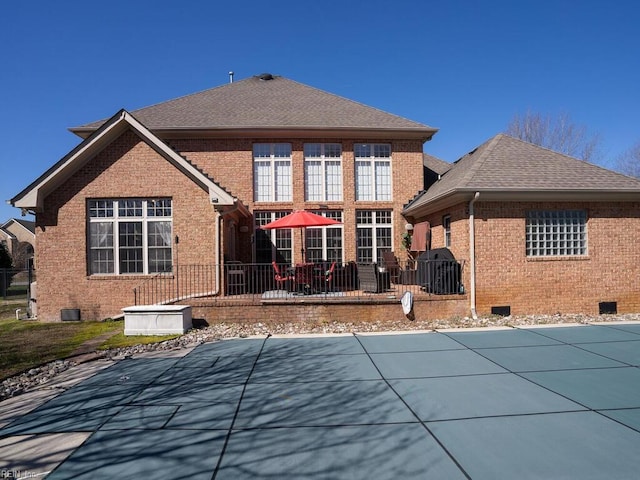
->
xmin=36 ymin=132 xmax=216 ymax=321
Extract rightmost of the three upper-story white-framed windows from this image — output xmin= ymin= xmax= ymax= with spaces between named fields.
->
xmin=353 ymin=143 xmax=392 ymax=201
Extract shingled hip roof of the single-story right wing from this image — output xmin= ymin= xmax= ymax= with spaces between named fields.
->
xmin=403 ymin=134 xmax=640 ymax=216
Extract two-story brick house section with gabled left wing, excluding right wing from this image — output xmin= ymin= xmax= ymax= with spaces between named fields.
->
xmin=11 ymin=74 xmax=437 ymax=320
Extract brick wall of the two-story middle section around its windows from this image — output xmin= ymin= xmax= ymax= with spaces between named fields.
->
xmin=169 ymin=138 xmax=423 ymax=263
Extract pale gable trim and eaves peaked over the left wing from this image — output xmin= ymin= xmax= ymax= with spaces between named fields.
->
xmin=9 ymin=110 xmax=248 ymax=215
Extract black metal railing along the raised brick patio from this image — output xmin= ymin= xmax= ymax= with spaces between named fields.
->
xmin=133 ymin=260 xmax=465 ymax=305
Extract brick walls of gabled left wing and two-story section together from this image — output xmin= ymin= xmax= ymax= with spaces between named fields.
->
xmin=36 ymin=131 xmax=423 ymax=321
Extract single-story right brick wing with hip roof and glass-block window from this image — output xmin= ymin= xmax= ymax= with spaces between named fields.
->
xmin=403 ymin=134 xmax=640 ymax=314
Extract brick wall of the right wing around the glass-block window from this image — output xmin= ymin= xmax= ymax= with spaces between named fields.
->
xmin=418 ymin=201 xmax=640 ymax=315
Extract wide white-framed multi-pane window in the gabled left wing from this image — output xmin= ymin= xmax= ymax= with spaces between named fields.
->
xmin=87 ymin=198 xmax=173 ymax=275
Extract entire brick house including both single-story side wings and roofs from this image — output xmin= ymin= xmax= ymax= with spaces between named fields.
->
xmin=11 ymin=74 xmax=640 ymax=321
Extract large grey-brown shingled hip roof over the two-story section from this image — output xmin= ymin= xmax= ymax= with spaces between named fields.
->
xmin=71 ymin=74 xmax=437 ymax=141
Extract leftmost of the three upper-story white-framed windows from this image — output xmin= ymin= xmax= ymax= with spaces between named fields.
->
xmin=253 ymin=143 xmax=292 ymax=202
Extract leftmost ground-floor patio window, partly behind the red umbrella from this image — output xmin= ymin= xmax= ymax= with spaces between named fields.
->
xmin=254 ymin=211 xmax=293 ymax=264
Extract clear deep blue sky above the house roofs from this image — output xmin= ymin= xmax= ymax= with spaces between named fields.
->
xmin=0 ymin=0 xmax=640 ymax=221
